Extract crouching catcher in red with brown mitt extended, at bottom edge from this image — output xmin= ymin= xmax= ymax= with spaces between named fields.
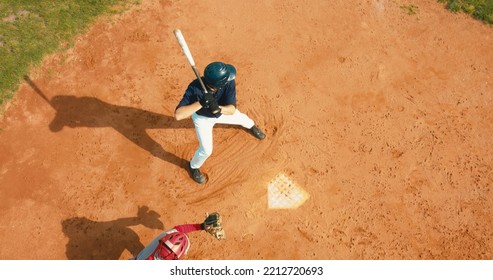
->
xmin=133 ymin=212 xmax=225 ymax=260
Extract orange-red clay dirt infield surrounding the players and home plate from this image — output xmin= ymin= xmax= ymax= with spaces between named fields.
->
xmin=0 ymin=0 xmax=493 ymax=260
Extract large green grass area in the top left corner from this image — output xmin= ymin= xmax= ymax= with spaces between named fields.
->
xmin=0 ymin=0 xmax=138 ymax=107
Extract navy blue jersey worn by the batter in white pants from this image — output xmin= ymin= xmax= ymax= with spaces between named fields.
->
xmin=175 ymin=79 xmax=236 ymax=118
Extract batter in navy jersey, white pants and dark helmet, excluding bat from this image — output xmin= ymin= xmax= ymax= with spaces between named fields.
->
xmin=175 ymin=62 xmax=265 ymax=184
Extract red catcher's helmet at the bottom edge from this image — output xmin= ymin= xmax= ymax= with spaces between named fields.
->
xmin=150 ymin=231 xmax=190 ymax=260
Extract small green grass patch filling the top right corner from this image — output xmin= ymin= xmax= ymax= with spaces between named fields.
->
xmin=438 ymin=0 xmax=493 ymax=25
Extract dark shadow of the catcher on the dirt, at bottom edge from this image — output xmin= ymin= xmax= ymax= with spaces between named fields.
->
xmin=62 ymin=206 xmax=164 ymax=260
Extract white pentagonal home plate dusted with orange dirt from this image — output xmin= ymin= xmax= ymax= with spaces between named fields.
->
xmin=267 ymin=173 xmax=310 ymax=209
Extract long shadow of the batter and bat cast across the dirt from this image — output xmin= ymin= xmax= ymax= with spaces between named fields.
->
xmin=24 ymin=76 xmax=193 ymax=169
